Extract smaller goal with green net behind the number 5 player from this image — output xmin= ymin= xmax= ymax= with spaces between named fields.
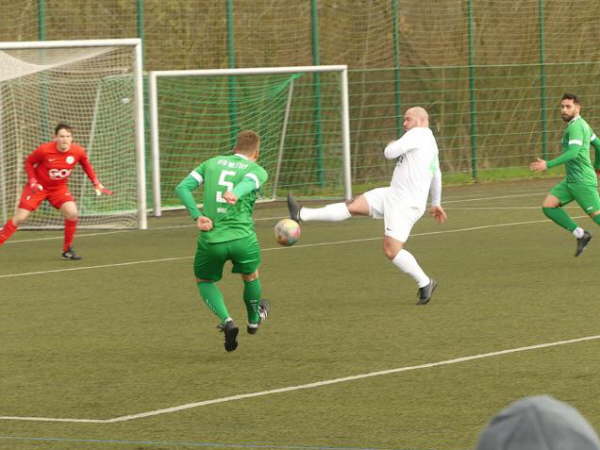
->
xmin=150 ymin=66 xmax=352 ymax=215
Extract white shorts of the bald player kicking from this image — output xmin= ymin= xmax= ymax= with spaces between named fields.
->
xmin=363 ymin=187 xmax=425 ymax=242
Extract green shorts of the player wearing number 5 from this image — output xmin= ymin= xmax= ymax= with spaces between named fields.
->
xmin=194 ymin=234 xmax=261 ymax=281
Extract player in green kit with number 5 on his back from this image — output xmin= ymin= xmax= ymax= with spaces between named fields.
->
xmin=176 ymin=130 xmax=268 ymax=352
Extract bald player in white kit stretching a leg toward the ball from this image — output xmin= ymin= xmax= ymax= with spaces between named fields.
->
xmin=288 ymin=106 xmax=447 ymax=305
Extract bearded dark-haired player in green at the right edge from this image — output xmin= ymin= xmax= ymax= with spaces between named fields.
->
xmin=529 ymin=94 xmax=600 ymax=256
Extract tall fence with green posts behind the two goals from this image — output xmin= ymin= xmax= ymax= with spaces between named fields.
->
xmin=0 ymin=0 xmax=600 ymax=185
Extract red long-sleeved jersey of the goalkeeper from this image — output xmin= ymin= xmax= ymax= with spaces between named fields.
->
xmin=25 ymin=141 xmax=98 ymax=189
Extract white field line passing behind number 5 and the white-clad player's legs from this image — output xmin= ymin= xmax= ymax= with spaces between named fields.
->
xmin=0 ymin=216 xmax=568 ymax=279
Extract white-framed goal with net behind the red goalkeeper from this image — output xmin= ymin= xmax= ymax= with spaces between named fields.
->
xmin=0 ymin=39 xmax=146 ymax=228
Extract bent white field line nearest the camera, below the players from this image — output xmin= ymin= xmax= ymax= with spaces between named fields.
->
xmin=0 ymin=335 xmax=600 ymax=423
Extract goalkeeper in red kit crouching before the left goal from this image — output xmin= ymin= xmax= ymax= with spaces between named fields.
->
xmin=0 ymin=123 xmax=112 ymax=260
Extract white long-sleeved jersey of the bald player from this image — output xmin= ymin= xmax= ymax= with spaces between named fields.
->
xmin=384 ymin=127 xmax=442 ymax=210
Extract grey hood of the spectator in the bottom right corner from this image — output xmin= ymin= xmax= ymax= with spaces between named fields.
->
xmin=477 ymin=395 xmax=600 ymax=450
